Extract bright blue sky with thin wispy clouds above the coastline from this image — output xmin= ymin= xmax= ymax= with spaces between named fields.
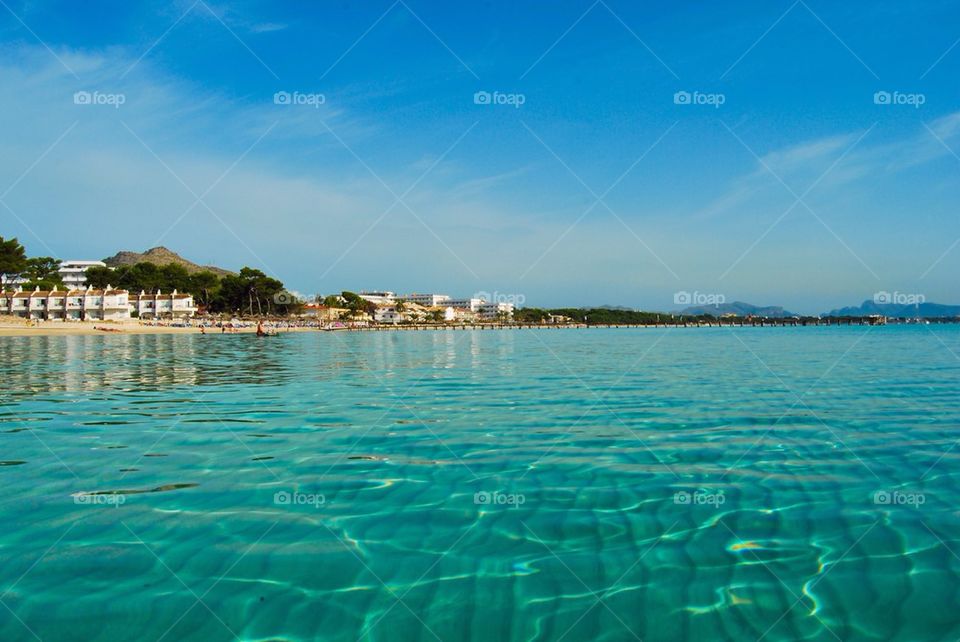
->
xmin=0 ymin=0 xmax=960 ymax=314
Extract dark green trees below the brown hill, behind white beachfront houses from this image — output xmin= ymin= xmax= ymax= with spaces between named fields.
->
xmin=86 ymin=263 xmax=301 ymax=315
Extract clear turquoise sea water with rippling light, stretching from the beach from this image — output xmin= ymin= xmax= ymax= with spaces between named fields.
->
xmin=0 ymin=326 xmax=960 ymax=642
